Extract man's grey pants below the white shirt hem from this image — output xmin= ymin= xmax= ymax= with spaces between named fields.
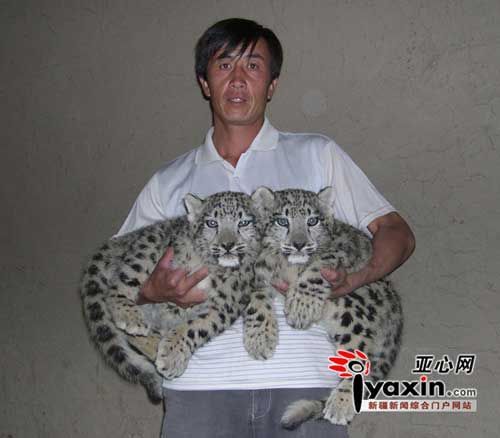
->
xmin=161 ymin=388 xmax=348 ymax=438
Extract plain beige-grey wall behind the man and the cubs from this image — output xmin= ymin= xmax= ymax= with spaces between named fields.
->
xmin=0 ymin=0 xmax=500 ymax=438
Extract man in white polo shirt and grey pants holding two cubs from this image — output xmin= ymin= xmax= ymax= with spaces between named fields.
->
xmin=120 ymin=19 xmax=414 ymax=438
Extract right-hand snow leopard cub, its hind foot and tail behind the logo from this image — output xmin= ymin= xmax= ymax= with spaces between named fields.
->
xmin=246 ymin=187 xmax=403 ymax=429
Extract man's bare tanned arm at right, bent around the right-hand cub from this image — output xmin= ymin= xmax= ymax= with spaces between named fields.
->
xmin=321 ymin=212 xmax=415 ymax=297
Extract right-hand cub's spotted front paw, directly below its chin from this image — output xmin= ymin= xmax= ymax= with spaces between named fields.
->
xmin=284 ymin=262 xmax=331 ymax=329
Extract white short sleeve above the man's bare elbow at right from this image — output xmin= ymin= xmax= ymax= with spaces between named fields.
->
xmin=325 ymin=141 xmax=395 ymax=236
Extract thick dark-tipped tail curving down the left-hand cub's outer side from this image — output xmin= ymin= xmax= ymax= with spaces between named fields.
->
xmin=80 ymin=243 xmax=163 ymax=403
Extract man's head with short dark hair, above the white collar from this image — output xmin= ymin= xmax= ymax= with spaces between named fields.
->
xmin=196 ymin=18 xmax=283 ymax=130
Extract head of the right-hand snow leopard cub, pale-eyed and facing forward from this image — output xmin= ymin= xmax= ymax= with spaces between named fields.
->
xmin=252 ymin=187 xmax=334 ymax=264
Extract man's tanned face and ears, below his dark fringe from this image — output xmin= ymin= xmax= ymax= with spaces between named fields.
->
xmin=198 ymin=39 xmax=278 ymax=126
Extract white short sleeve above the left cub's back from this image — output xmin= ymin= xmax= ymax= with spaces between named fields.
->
xmin=115 ymin=174 xmax=166 ymax=237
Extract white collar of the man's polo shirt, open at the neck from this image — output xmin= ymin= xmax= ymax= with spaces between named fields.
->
xmin=196 ymin=117 xmax=279 ymax=164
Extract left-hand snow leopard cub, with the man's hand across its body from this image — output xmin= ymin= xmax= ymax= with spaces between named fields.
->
xmin=81 ymin=192 xmax=260 ymax=402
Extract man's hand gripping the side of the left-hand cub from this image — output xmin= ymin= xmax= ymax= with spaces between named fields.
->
xmin=137 ymin=248 xmax=208 ymax=308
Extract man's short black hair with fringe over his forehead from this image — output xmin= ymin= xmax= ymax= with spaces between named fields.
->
xmin=194 ymin=18 xmax=283 ymax=80
